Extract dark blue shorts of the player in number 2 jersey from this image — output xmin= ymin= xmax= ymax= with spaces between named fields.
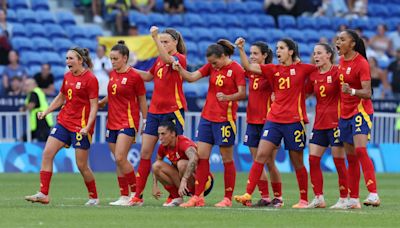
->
xmin=310 ymin=128 xmax=343 ymax=147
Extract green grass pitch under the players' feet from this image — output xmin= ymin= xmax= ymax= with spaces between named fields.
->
xmin=0 ymin=173 xmax=400 ymax=228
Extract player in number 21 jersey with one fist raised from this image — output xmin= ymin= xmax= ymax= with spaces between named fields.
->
xmin=235 ymin=38 xmax=316 ymax=208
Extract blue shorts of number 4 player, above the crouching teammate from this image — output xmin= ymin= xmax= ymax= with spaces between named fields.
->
xmin=144 ymin=109 xmax=185 ymax=137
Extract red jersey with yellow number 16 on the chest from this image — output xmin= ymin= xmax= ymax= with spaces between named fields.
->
xmin=199 ymin=61 xmax=246 ymax=123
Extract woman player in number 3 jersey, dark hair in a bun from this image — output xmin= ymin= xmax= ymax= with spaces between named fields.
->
xmin=99 ymin=40 xmax=147 ymax=206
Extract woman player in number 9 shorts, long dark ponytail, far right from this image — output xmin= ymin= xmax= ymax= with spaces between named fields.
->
xmin=336 ymin=30 xmax=380 ymax=208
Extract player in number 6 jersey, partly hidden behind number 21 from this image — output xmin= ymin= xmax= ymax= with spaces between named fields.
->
xmin=244 ymin=41 xmax=281 ymax=207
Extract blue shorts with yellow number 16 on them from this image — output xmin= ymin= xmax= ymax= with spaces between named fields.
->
xmin=196 ymin=117 xmax=236 ymax=146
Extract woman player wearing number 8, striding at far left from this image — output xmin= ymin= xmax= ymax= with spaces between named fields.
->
xmin=25 ymin=47 xmax=99 ymax=206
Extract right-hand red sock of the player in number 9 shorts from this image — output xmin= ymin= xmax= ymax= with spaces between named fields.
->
xmin=356 ymin=147 xmax=376 ymax=193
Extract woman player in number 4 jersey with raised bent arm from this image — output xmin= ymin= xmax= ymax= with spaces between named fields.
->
xmin=131 ymin=26 xmax=186 ymax=206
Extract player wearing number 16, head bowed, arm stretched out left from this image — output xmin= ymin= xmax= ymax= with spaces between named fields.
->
xmin=174 ymin=39 xmax=246 ymax=207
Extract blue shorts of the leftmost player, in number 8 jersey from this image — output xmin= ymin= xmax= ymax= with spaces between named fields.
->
xmin=50 ymin=123 xmax=92 ymax=150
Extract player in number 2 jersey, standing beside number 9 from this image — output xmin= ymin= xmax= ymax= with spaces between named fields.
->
xmin=307 ymin=43 xmax=348 ymax=208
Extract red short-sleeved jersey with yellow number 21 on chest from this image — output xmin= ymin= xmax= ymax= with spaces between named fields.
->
xmin=260 ymin=63 xmax=317 ymax=124
